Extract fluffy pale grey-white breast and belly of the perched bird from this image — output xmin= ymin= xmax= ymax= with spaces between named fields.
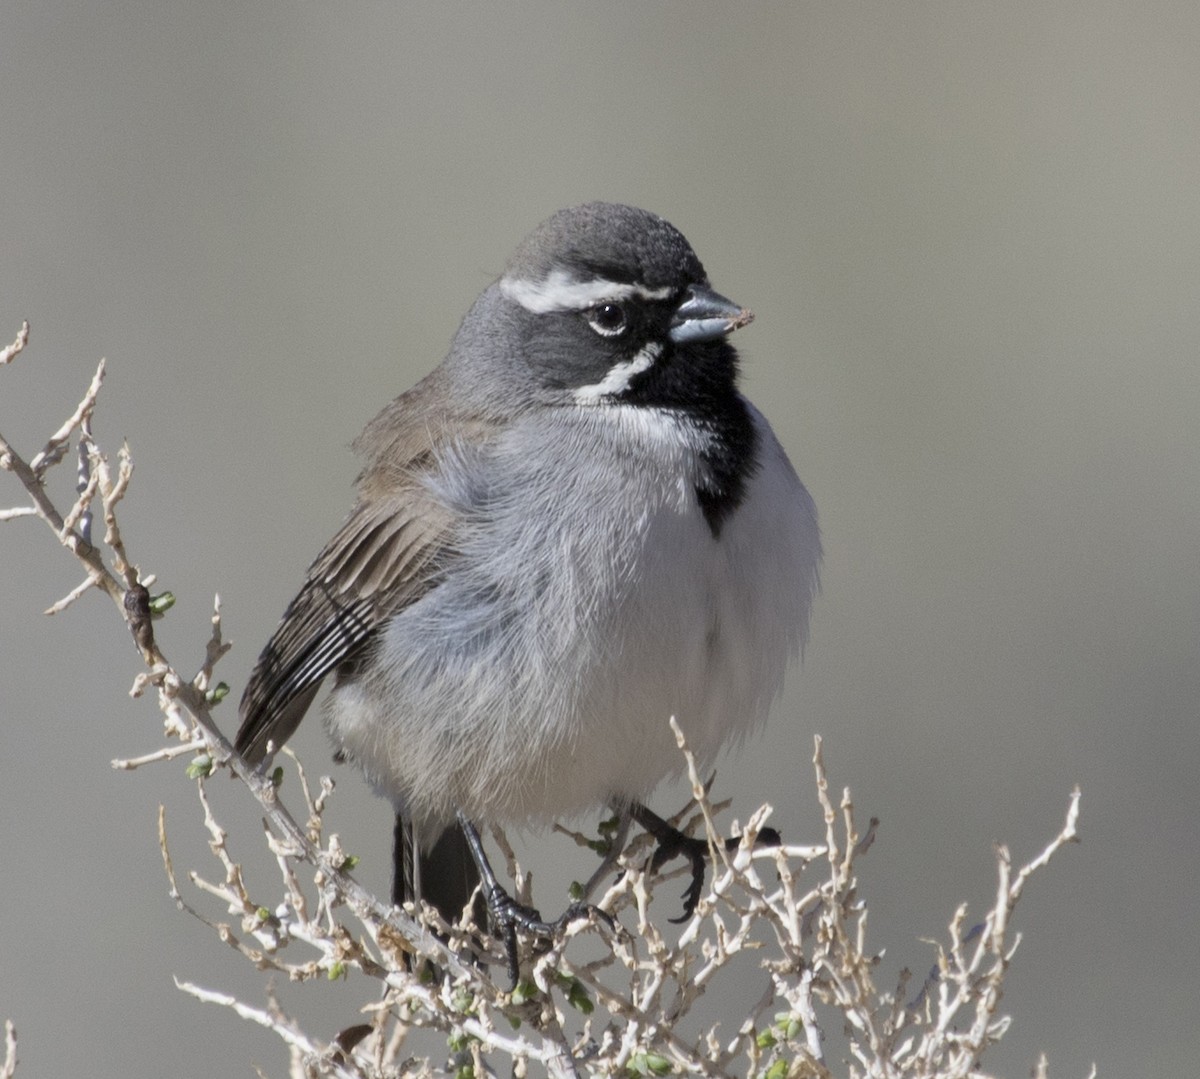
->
xmin=328 ymin=409 xmax=820 ymax=844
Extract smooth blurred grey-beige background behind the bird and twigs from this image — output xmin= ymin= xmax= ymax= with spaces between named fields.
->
xmin=0 ymin=0 xmax=1200 ymax=1077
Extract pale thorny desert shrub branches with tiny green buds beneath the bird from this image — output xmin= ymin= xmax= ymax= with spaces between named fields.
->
xmin=0 ymin=324 xmax=1079 ymax=1079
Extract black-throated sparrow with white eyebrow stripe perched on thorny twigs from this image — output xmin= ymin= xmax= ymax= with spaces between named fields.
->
xmin=236 ymin=202 xmax=821 ymax=979
